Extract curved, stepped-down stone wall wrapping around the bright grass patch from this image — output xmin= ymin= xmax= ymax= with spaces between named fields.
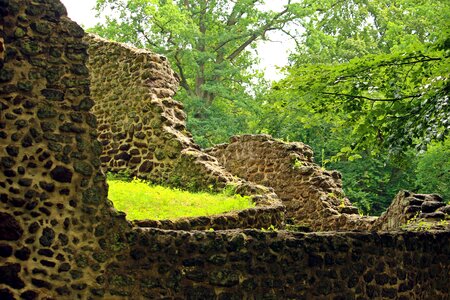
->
xmin=85 ymin=35 xmax=284 ymax=230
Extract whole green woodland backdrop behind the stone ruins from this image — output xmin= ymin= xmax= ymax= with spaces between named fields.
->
xmin=80 ymin=0 xmax=450 ymax=215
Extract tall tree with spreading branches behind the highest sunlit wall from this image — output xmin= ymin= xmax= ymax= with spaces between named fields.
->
xmin=90 ymin=0 xmax=328 ymax=144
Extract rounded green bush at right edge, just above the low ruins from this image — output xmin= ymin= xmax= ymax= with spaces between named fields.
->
xmin=416 ymin=139 xmax=450 ymax=202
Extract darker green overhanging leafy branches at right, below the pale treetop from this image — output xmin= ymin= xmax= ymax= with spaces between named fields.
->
xmin=281 ymin=45 xmax=450 ymax=154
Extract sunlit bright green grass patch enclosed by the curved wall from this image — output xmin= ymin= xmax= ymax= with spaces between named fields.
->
xmin=108 ymin=179 xmax=255 ymax=220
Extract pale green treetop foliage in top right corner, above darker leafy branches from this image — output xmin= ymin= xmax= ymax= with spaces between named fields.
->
xmin=292 ymin=0 xmax=449 ymax=65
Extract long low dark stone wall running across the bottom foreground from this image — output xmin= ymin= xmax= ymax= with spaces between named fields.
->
xmin=102 ymin=229 xmax=450 ymax=300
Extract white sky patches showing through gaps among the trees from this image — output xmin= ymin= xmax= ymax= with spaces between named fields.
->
xmin=61 ymin=0 xmax=294 ymax=80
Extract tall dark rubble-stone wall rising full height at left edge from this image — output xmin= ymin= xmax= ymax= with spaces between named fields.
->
xmin=0 ymin=0 xmax=126 ymax=299
